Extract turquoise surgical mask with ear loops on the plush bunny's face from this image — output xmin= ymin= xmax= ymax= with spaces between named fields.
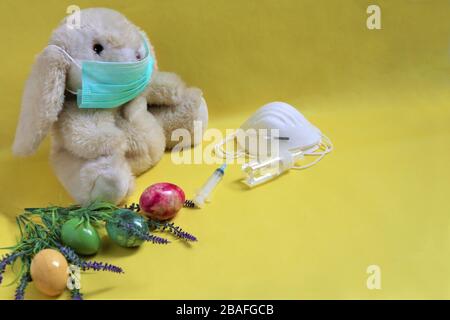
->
xmin=50 ymin=36 xmax=155 ymax=109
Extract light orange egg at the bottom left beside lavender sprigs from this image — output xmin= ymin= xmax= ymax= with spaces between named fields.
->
xmin=30 ymin=249 xmax=69 ymax=297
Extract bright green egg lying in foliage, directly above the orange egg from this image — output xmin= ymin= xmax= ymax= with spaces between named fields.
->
xmin=61 ymin=218 xmax=101 ymax=255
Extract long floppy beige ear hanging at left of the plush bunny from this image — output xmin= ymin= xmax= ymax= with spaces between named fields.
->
xmin=13 ymin=46 xmax=70 ymax=156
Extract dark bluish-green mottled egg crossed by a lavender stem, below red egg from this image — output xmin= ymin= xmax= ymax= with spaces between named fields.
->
xmin=106 ymin=209 xmax=148 ymax=248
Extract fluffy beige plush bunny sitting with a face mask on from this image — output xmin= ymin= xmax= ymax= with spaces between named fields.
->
xmin=13 ymin=8 xmax=208 ymax=204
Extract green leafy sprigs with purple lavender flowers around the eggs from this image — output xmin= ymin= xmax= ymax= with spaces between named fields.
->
xmin=0 ymin=201 xmax=197 ymax=299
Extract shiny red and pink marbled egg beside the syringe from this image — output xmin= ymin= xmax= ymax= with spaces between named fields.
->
xmin=139 ymin=182 xmax=186 ymax=220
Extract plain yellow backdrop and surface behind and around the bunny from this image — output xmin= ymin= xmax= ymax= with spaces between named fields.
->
xmin=0 ymin=0 xmax=450 ymax=299
